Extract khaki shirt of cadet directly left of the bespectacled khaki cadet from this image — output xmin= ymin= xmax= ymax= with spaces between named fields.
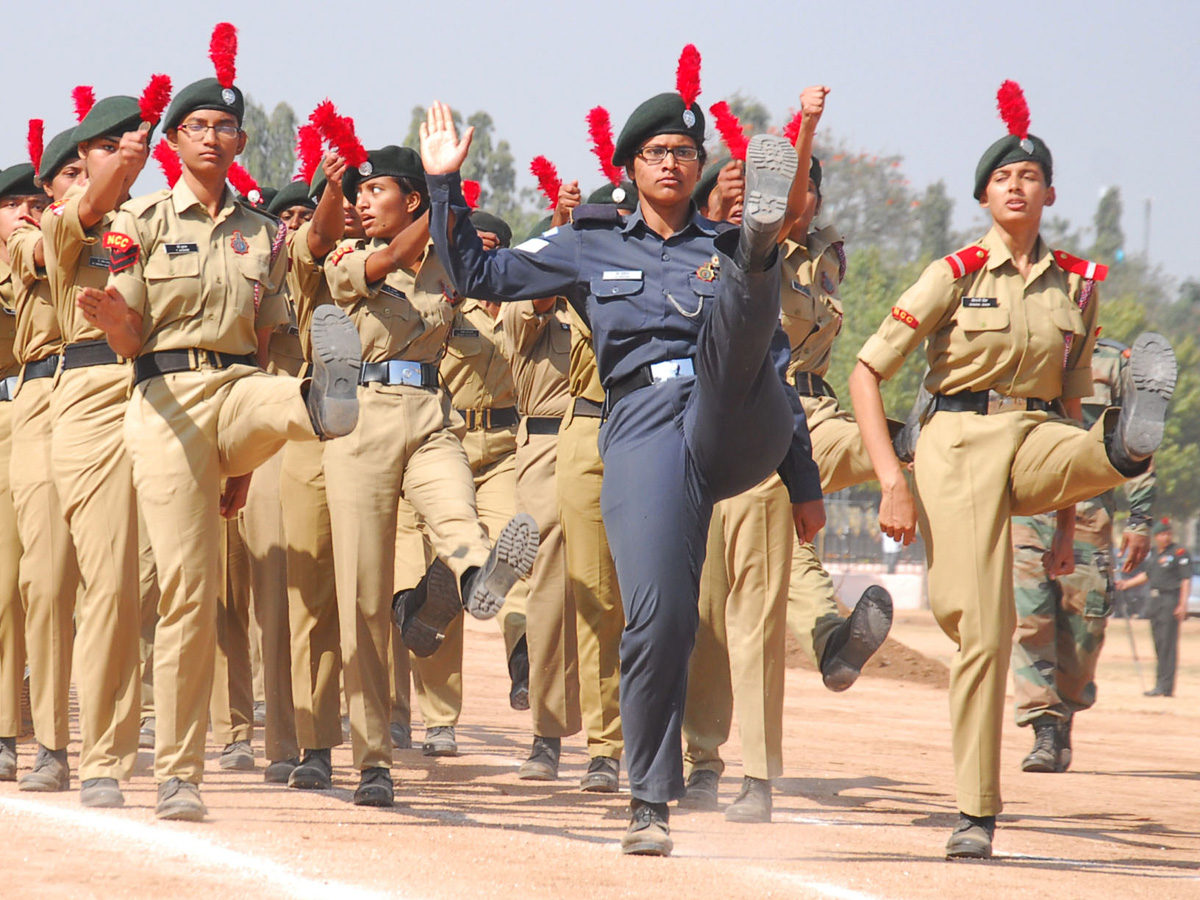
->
xmin=42 ymin=185 xmax=116 ymax=343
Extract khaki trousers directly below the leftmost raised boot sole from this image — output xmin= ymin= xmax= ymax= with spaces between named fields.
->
xmin=280 ymin=442 xmax=342 ymax=750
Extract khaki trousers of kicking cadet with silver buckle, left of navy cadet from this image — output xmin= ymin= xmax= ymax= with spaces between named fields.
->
xmin=324 ymin=385 xmax=490 ymax=769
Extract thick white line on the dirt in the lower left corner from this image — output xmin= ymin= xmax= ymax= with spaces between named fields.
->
xmin=0 ymin=797 xmax=401 ymax=900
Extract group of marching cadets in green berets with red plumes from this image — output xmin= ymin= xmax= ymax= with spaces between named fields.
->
xmin=0 ymin=24 xmax=1175 ymax=857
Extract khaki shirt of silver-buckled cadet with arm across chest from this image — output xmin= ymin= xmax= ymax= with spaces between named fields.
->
xmin=324 ymin=239 xmax=454 ymax=362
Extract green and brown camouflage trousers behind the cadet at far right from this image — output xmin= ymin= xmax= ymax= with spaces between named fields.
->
xmin=1013 ymin=500 xmax=1112 ymax=725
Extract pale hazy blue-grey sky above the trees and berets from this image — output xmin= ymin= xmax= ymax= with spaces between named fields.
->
xmin=0 ymin=0 xmax=1200 ymax=285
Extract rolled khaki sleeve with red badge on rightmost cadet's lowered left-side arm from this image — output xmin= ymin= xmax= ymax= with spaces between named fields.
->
xmin=858 ymin=260 xmax=958 ymax=380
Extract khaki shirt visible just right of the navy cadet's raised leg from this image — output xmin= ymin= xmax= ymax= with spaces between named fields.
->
xmin=780 ymin=226 xmax=846 ymax=380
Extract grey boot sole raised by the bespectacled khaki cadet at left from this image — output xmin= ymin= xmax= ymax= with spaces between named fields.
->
xmin=308 ymin=304 xmax=362 ymax=438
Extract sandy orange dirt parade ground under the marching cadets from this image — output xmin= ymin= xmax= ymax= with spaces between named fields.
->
xmin=0 ymin=612 xmax=1200 ymax=900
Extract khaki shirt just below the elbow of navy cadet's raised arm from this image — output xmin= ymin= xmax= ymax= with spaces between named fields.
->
xmin=440 ymin=298 xmax=517 ymax=409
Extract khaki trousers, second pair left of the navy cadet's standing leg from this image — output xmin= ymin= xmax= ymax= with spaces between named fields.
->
xmin=516 ymin=426 xmax=583 ymax=738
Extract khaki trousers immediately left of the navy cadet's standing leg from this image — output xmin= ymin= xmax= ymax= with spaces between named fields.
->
xmin=556 ymin=412 xmax=625 ymax=760
